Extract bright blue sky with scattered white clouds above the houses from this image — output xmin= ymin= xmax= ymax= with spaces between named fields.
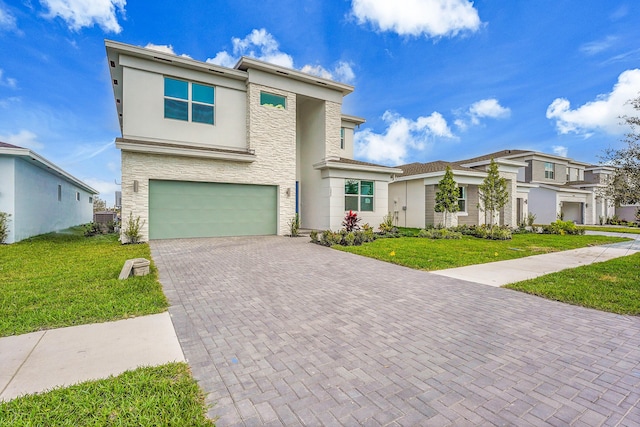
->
xmin=0 ymin=0 xmax=640 ymax=204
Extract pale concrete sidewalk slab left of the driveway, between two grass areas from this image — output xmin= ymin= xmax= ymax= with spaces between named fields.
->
xmin=0 ymin=313 xmax=185 ymax=401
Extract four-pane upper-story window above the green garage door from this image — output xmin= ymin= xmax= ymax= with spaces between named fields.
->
xmin=164 ymin=77 xmax=215 ymax=125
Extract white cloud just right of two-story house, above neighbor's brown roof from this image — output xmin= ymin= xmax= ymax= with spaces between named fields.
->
xmin=354 ymin=111 xmax=455 ymax=165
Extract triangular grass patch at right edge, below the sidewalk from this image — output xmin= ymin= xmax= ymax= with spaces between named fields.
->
xmin=505 ymin=253 xmax=640 ymax=316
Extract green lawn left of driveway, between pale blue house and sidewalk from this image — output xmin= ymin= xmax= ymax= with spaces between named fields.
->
xmin=0 ymin=227 xmax=168 ymax=336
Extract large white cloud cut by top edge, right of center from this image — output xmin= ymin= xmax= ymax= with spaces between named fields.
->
xmin=352 ymin=0 xmax=481 ymax=37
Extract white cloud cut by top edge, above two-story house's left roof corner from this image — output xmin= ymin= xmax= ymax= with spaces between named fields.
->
xmin=40 ymin=0 xmax=127 ymax=33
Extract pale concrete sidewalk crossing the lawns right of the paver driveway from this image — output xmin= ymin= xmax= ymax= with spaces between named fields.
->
xmin=432 ymin=231 xmax=640 ymax=286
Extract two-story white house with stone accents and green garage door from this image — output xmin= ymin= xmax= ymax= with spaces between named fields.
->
xmin=105 ymin=41 xmax=400 ymax=240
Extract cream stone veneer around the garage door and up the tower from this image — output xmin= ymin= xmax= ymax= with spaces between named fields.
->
xmin=122 ymin=84 xmax=298 ymax=241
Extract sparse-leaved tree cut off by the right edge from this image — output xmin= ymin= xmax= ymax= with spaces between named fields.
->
xmin=601 ymin=96 xmax=640 ymax=206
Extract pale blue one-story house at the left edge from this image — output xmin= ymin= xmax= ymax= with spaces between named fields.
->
xmin=0 ymin=142 xmax=98 ymax=243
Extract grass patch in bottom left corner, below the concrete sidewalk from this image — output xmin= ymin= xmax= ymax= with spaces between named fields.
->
xmin=0 ymin=363 xmax=214 ymax=427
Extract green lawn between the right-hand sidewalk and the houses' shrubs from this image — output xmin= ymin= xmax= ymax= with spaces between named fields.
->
xmin=332 ymin=234 xmax=628 ymax=271
